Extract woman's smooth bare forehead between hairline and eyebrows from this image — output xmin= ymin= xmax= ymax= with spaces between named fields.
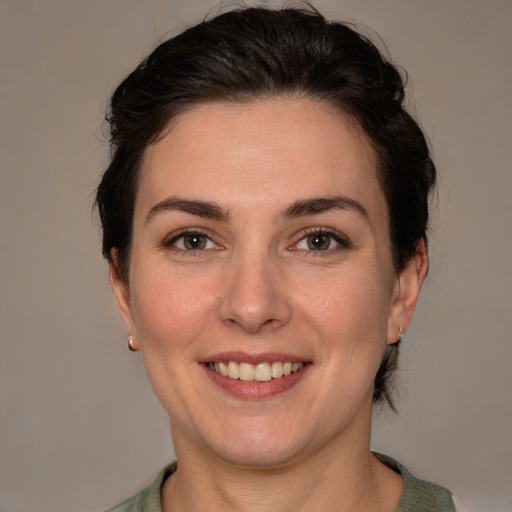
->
xmin=136 ymin=99 xmax=383 ymax=220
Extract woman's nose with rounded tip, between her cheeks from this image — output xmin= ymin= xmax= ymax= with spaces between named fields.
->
xmin=219 ymin=250 xmax=292 ymax=334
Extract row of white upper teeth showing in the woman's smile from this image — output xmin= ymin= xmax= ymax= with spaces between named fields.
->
xmin=207 ymin=361 xmax=304 ymax=382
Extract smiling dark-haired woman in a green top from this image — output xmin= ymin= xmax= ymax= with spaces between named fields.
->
xmin=97 ymin=8 xmax=453 ymax=512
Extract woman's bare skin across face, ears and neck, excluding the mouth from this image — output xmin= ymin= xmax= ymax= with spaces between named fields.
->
xmin=110 ymin=98 xmax=427 ymax=512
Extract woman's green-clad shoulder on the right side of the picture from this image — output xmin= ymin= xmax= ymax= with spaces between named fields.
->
xmin=375 ymin=453 xmax=455 ymax=512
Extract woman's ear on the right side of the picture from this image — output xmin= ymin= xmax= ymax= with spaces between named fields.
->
xmin=387 ymin=239 xmax=428 ymax=344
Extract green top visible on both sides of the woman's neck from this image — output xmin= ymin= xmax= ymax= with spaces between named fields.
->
xmin=106 ymin=453 xmax=455 ymax=512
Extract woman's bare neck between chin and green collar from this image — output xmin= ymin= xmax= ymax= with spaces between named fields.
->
xmin=162 ymin=412 xmax=403 ymax=512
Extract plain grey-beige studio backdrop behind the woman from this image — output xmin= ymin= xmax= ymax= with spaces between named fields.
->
xmin=0 ymin=0 xmax=512 ymax=512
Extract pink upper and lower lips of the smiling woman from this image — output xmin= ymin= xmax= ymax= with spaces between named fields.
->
xmin=199 ymin=352 xmax=312 ymax=400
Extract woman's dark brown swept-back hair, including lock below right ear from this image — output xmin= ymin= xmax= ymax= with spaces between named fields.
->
xmin=96 ymin=6 xmax=436 ymax=409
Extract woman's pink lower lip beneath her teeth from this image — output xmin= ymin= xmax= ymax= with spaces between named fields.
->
xmin=202 ymin=364 xmax=311 ymax=400
